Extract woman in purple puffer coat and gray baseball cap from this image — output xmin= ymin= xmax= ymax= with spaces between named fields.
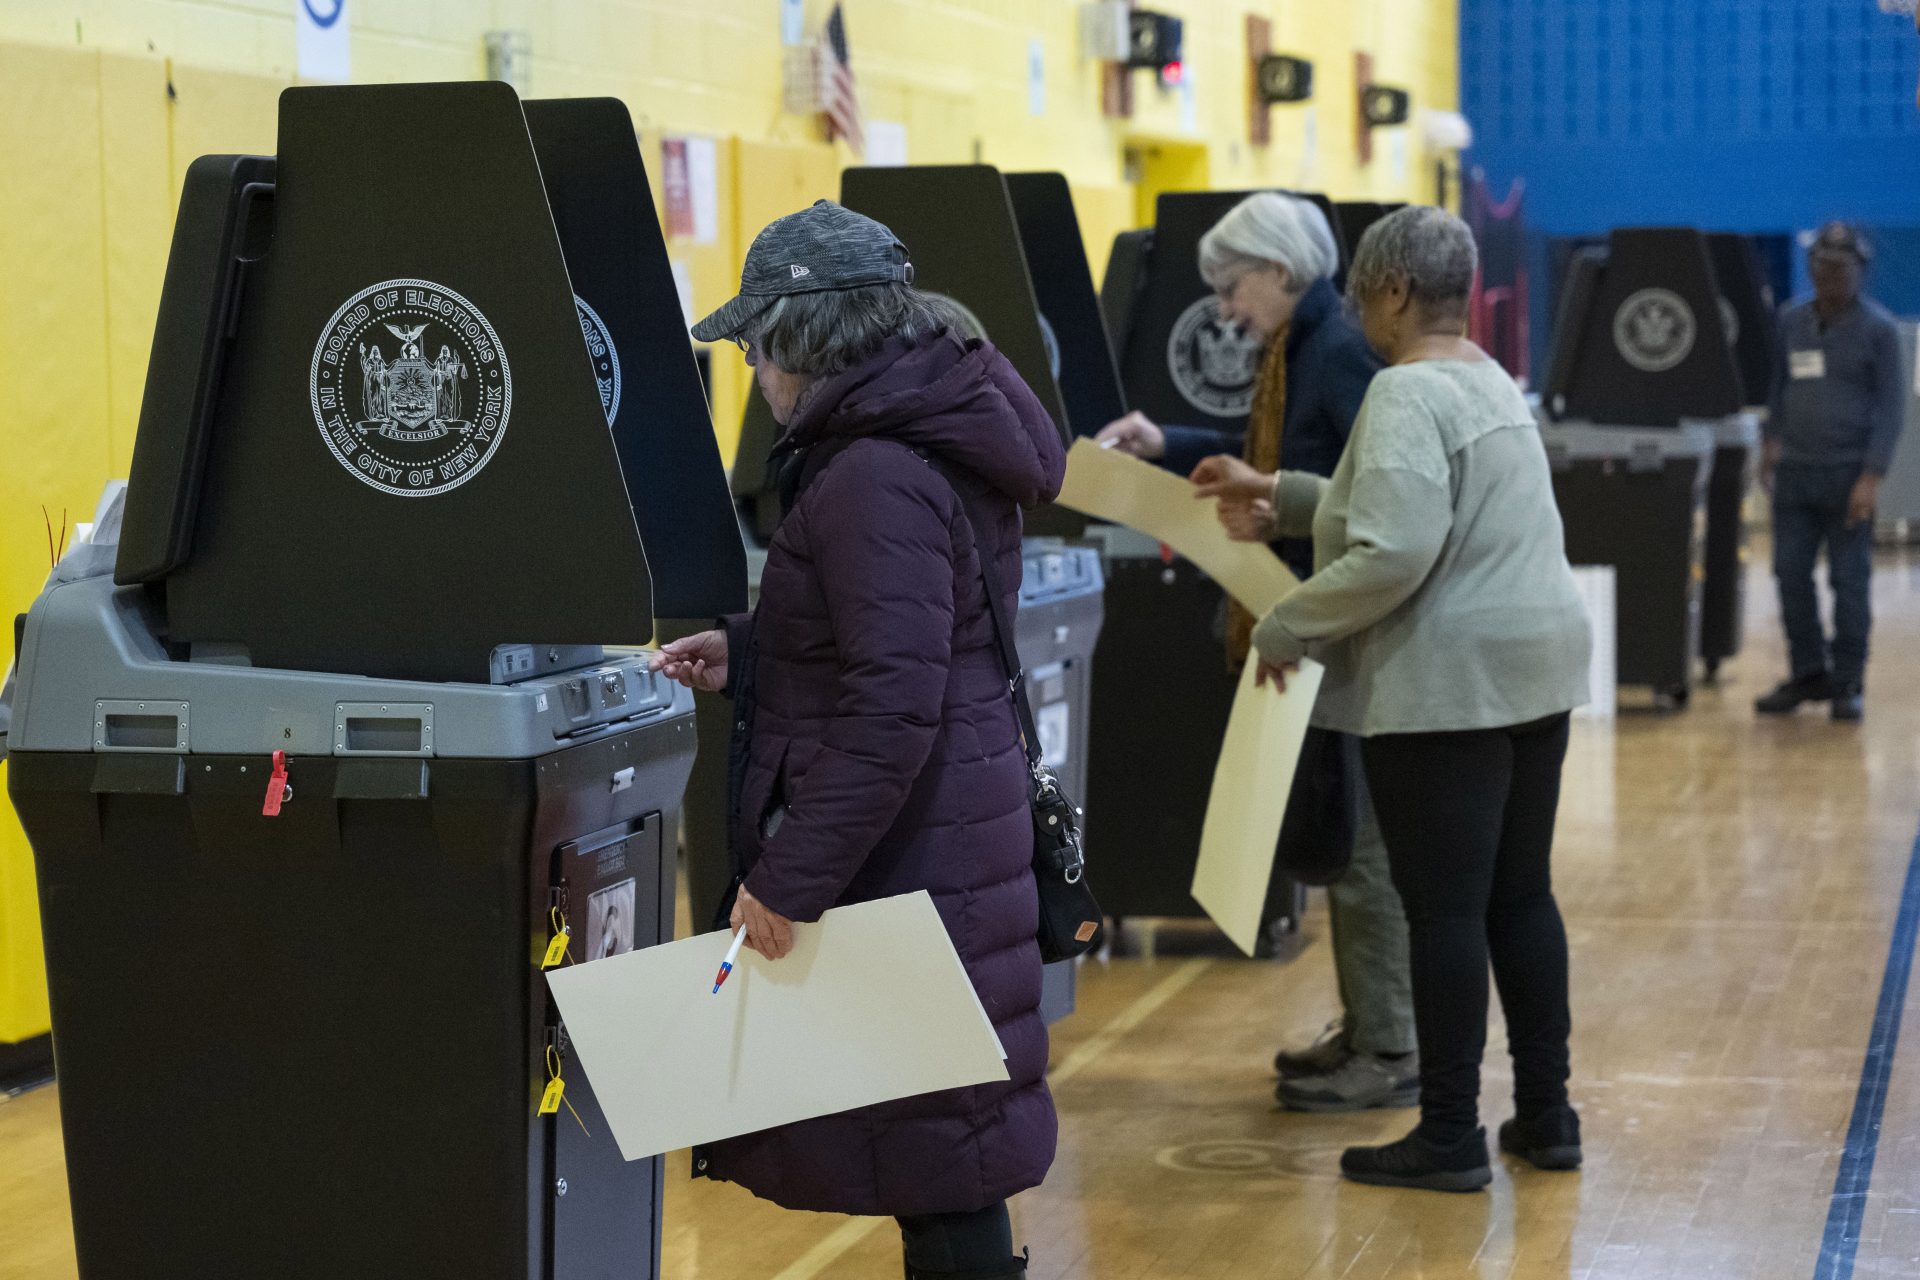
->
xmin=655 ymin=201 xmax=1066 ymax=1280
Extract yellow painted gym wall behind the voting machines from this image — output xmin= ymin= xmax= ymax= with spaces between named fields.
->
xmin=0 ymin=0 xmax=1457 ymax=1042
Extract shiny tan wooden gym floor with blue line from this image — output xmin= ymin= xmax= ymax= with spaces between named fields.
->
xmin=0 ymin=555 xmax=1920 ymax=1280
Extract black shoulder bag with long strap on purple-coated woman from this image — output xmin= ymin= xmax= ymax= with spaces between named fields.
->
xmin=933 ymin=468 xmax=1106 ymax=963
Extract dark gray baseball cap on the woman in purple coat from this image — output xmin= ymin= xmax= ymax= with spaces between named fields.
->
xmin=693 ymin=200 xmax=914 ymax=342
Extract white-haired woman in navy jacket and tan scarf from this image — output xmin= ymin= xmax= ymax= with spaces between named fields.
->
xmin=1100 ymin=192 xmax=1419 ymax=1111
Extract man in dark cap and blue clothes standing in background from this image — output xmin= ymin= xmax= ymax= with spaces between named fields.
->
xmin=1753 ymin=223 xmax=1905 ymax=722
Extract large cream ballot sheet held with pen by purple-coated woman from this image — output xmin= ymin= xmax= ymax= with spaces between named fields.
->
xmin=547 ymin=892 xmax=1008 ymax=1159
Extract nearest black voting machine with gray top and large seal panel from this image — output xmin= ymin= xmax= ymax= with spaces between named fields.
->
xmin=10 ymin=83 xmax=745 ymax=1280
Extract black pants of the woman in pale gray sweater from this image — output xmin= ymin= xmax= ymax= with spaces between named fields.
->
xmin=1361 ymin=716 xmax=1572 ymax=1142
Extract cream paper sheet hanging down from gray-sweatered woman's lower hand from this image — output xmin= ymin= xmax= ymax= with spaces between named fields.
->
xmin=1192 ymin=658 xmax=1325 ymax=956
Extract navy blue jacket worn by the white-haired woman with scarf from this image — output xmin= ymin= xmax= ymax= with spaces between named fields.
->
xmin=1160 ymin=280 xmax=1380 ymax=578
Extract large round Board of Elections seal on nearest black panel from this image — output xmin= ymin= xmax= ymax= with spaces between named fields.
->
xmin=307 ymin=280 xmax=513 ymax=497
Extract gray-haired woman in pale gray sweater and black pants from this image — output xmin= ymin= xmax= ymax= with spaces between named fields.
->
xmin=1204 ymin=207 xmax=1590 ymax=1192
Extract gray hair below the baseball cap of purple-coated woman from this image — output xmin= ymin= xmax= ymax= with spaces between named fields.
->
xmin=741 ymin=284 xmax=948 ymax=378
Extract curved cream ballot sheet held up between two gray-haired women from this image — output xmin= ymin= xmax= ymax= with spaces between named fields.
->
xmin=1060 ymin=439 xmax=1300 ymax=618
